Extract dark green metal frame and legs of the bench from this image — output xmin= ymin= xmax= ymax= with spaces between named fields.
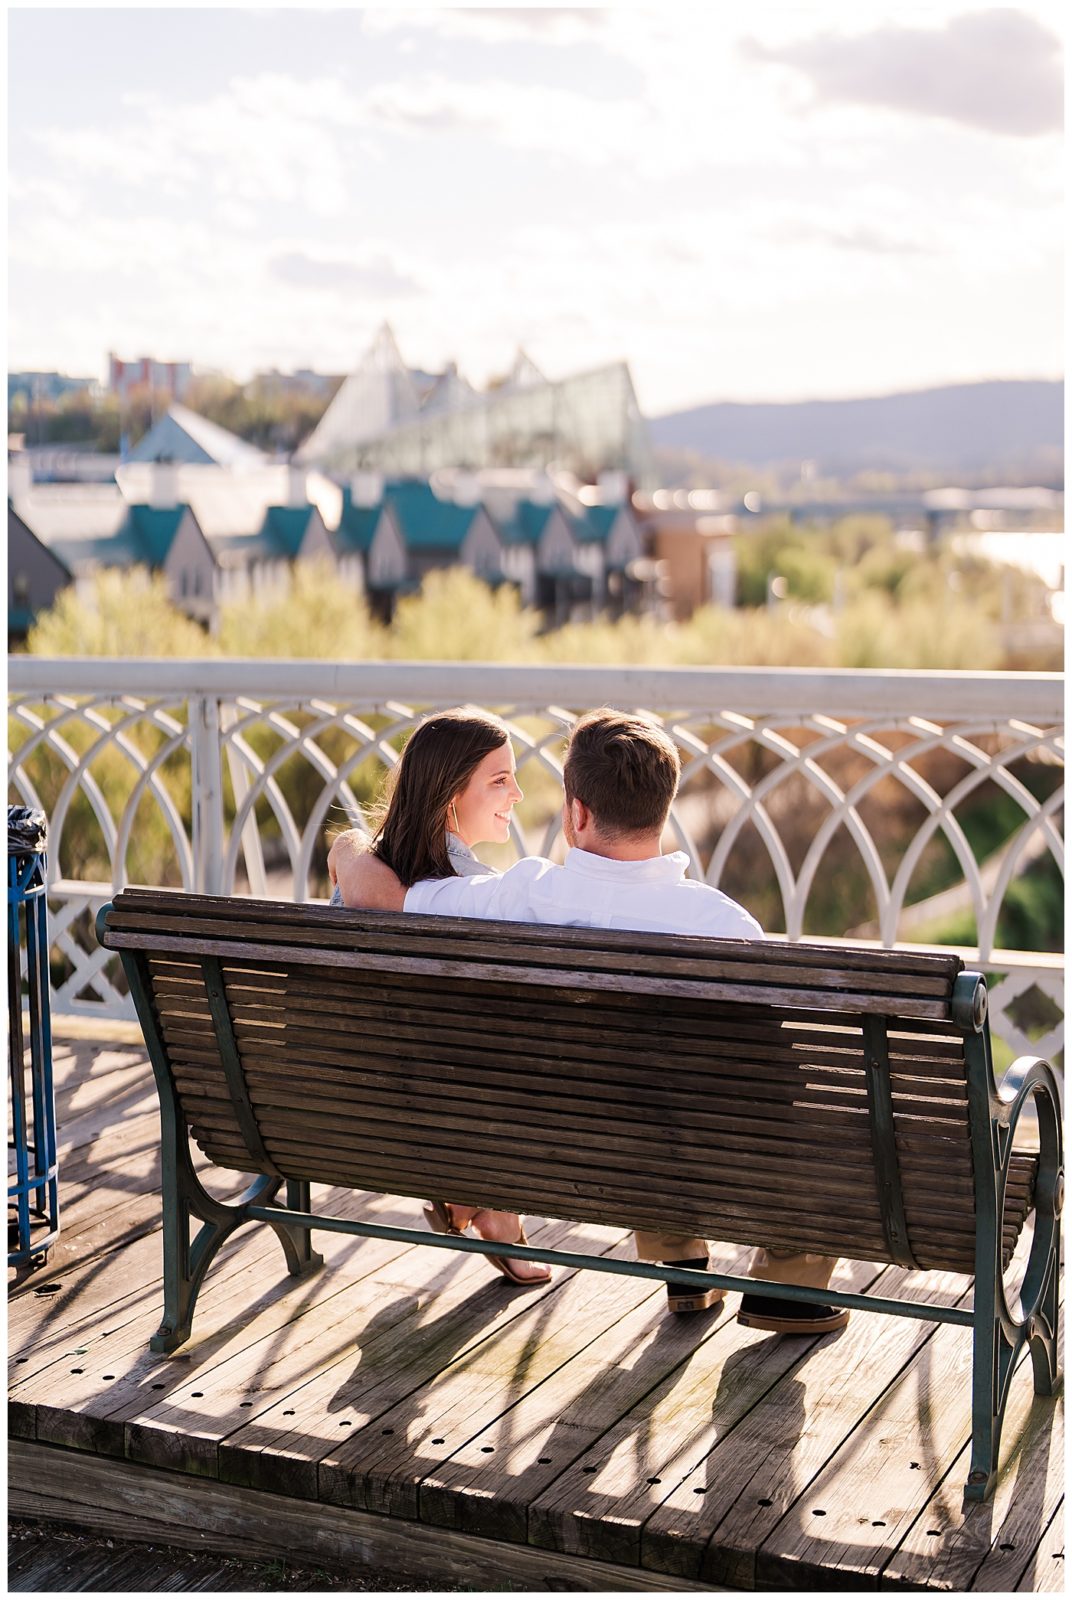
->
xmin=98 ymin=906 xmax=1064 ymax=1501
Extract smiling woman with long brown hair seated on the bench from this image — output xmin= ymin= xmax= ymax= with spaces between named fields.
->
xmin=331 ymin=710 xmax=550 ymax=1288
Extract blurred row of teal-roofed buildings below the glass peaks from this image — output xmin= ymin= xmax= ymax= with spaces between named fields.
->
xmin=8 ymin=405 xmax=653 ymax=637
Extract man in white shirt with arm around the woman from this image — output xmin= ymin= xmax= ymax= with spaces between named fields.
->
xmin=328 ymin=709 xmax=848 ymax=1333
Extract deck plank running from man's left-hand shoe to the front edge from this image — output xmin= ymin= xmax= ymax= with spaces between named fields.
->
xmin=419 ymin=1246 xmax=752 ymax=1542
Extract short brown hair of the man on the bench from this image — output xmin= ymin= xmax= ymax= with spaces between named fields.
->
xmin=562 ymin=707 xmax=682 ymax=838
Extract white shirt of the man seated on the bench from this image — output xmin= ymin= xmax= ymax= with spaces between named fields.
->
xmin=405 ymin=848 xmax=765 ymax=939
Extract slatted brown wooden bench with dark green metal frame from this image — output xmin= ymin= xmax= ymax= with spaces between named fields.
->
xmin=98 ymin=890 xmax=1062 ymax=1499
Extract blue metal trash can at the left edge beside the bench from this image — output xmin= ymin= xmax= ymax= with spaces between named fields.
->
xmin=8 ymin=805 xmax=59 ymax=1266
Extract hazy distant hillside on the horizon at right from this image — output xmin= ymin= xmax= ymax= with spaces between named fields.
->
xmin=651 ymin=379 xmax=1064 ymax=475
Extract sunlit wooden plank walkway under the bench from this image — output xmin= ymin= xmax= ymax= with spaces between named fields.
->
xmin=8 ymin=1027 xmax=1064 ymax=1592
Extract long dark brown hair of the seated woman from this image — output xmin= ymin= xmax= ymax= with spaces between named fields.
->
xmin=373 ymin=710 xmax=510 ymax=888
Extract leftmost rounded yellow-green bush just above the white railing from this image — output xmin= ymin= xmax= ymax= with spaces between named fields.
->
xmin=26 ymin=566 xmax=216 ymax=659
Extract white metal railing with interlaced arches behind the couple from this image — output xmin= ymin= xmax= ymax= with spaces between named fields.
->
xmin=8 ymin=656 xmax=1064 ymax=1056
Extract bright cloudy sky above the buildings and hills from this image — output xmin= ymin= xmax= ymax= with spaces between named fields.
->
xmin=8 ymin=0 xmax=1062 ymax=416
